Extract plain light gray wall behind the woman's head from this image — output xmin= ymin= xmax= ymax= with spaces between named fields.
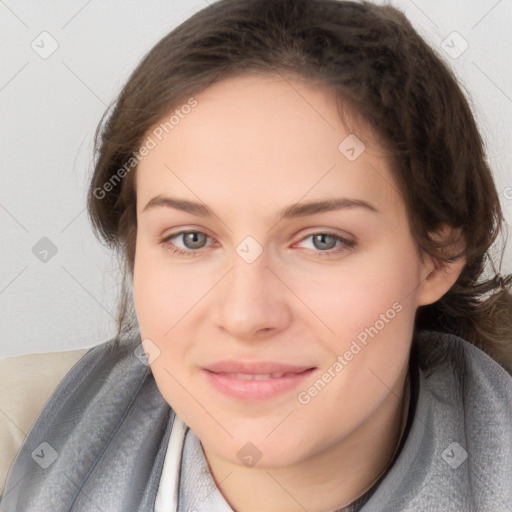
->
xmin=0 ymin=0 xmax=512 ymax=357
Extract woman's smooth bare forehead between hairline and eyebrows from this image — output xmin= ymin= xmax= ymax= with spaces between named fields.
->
xmin=136 ymin=74 xmax=404 ymax=218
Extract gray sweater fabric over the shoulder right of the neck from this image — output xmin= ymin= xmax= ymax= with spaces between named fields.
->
xmin=365 ymin=330 xmax=512 ymax=512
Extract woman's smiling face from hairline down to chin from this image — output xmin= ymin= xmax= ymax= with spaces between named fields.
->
xmin=134 ymin=75 xmax=436 ymax=467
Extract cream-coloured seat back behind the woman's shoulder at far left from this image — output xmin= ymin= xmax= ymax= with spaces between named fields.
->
xmin=0 ymin=348 xmax=89 ymax=494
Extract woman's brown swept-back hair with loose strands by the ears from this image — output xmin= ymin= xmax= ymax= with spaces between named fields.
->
xmin=88 ymin=0 xmax=512 ymax=372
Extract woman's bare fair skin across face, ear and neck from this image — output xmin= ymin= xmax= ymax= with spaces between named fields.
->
xmin=133 ymin=74 xmax=464 ymax=512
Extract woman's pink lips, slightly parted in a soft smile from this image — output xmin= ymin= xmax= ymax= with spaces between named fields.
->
xmin=203 ymin=361 xmax=315 ymax=400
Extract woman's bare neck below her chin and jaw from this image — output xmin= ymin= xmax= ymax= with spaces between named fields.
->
xmin=203 ymin=368 xmax=410 ymax=512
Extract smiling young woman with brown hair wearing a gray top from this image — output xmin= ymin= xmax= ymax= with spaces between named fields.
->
xmin=0 ymin=0 xmax=512 ymax=512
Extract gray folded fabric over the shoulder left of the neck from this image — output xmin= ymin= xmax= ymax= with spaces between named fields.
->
xmin=0 ymin=336 xmax=173 ymax=510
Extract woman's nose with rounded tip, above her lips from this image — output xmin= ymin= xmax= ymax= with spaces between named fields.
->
xmin=216 ymin=252 xmax=291 ymax=341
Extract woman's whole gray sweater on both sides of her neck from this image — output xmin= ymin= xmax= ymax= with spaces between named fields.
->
xmin=0 ymin=331 xmax=512 ymax=512
